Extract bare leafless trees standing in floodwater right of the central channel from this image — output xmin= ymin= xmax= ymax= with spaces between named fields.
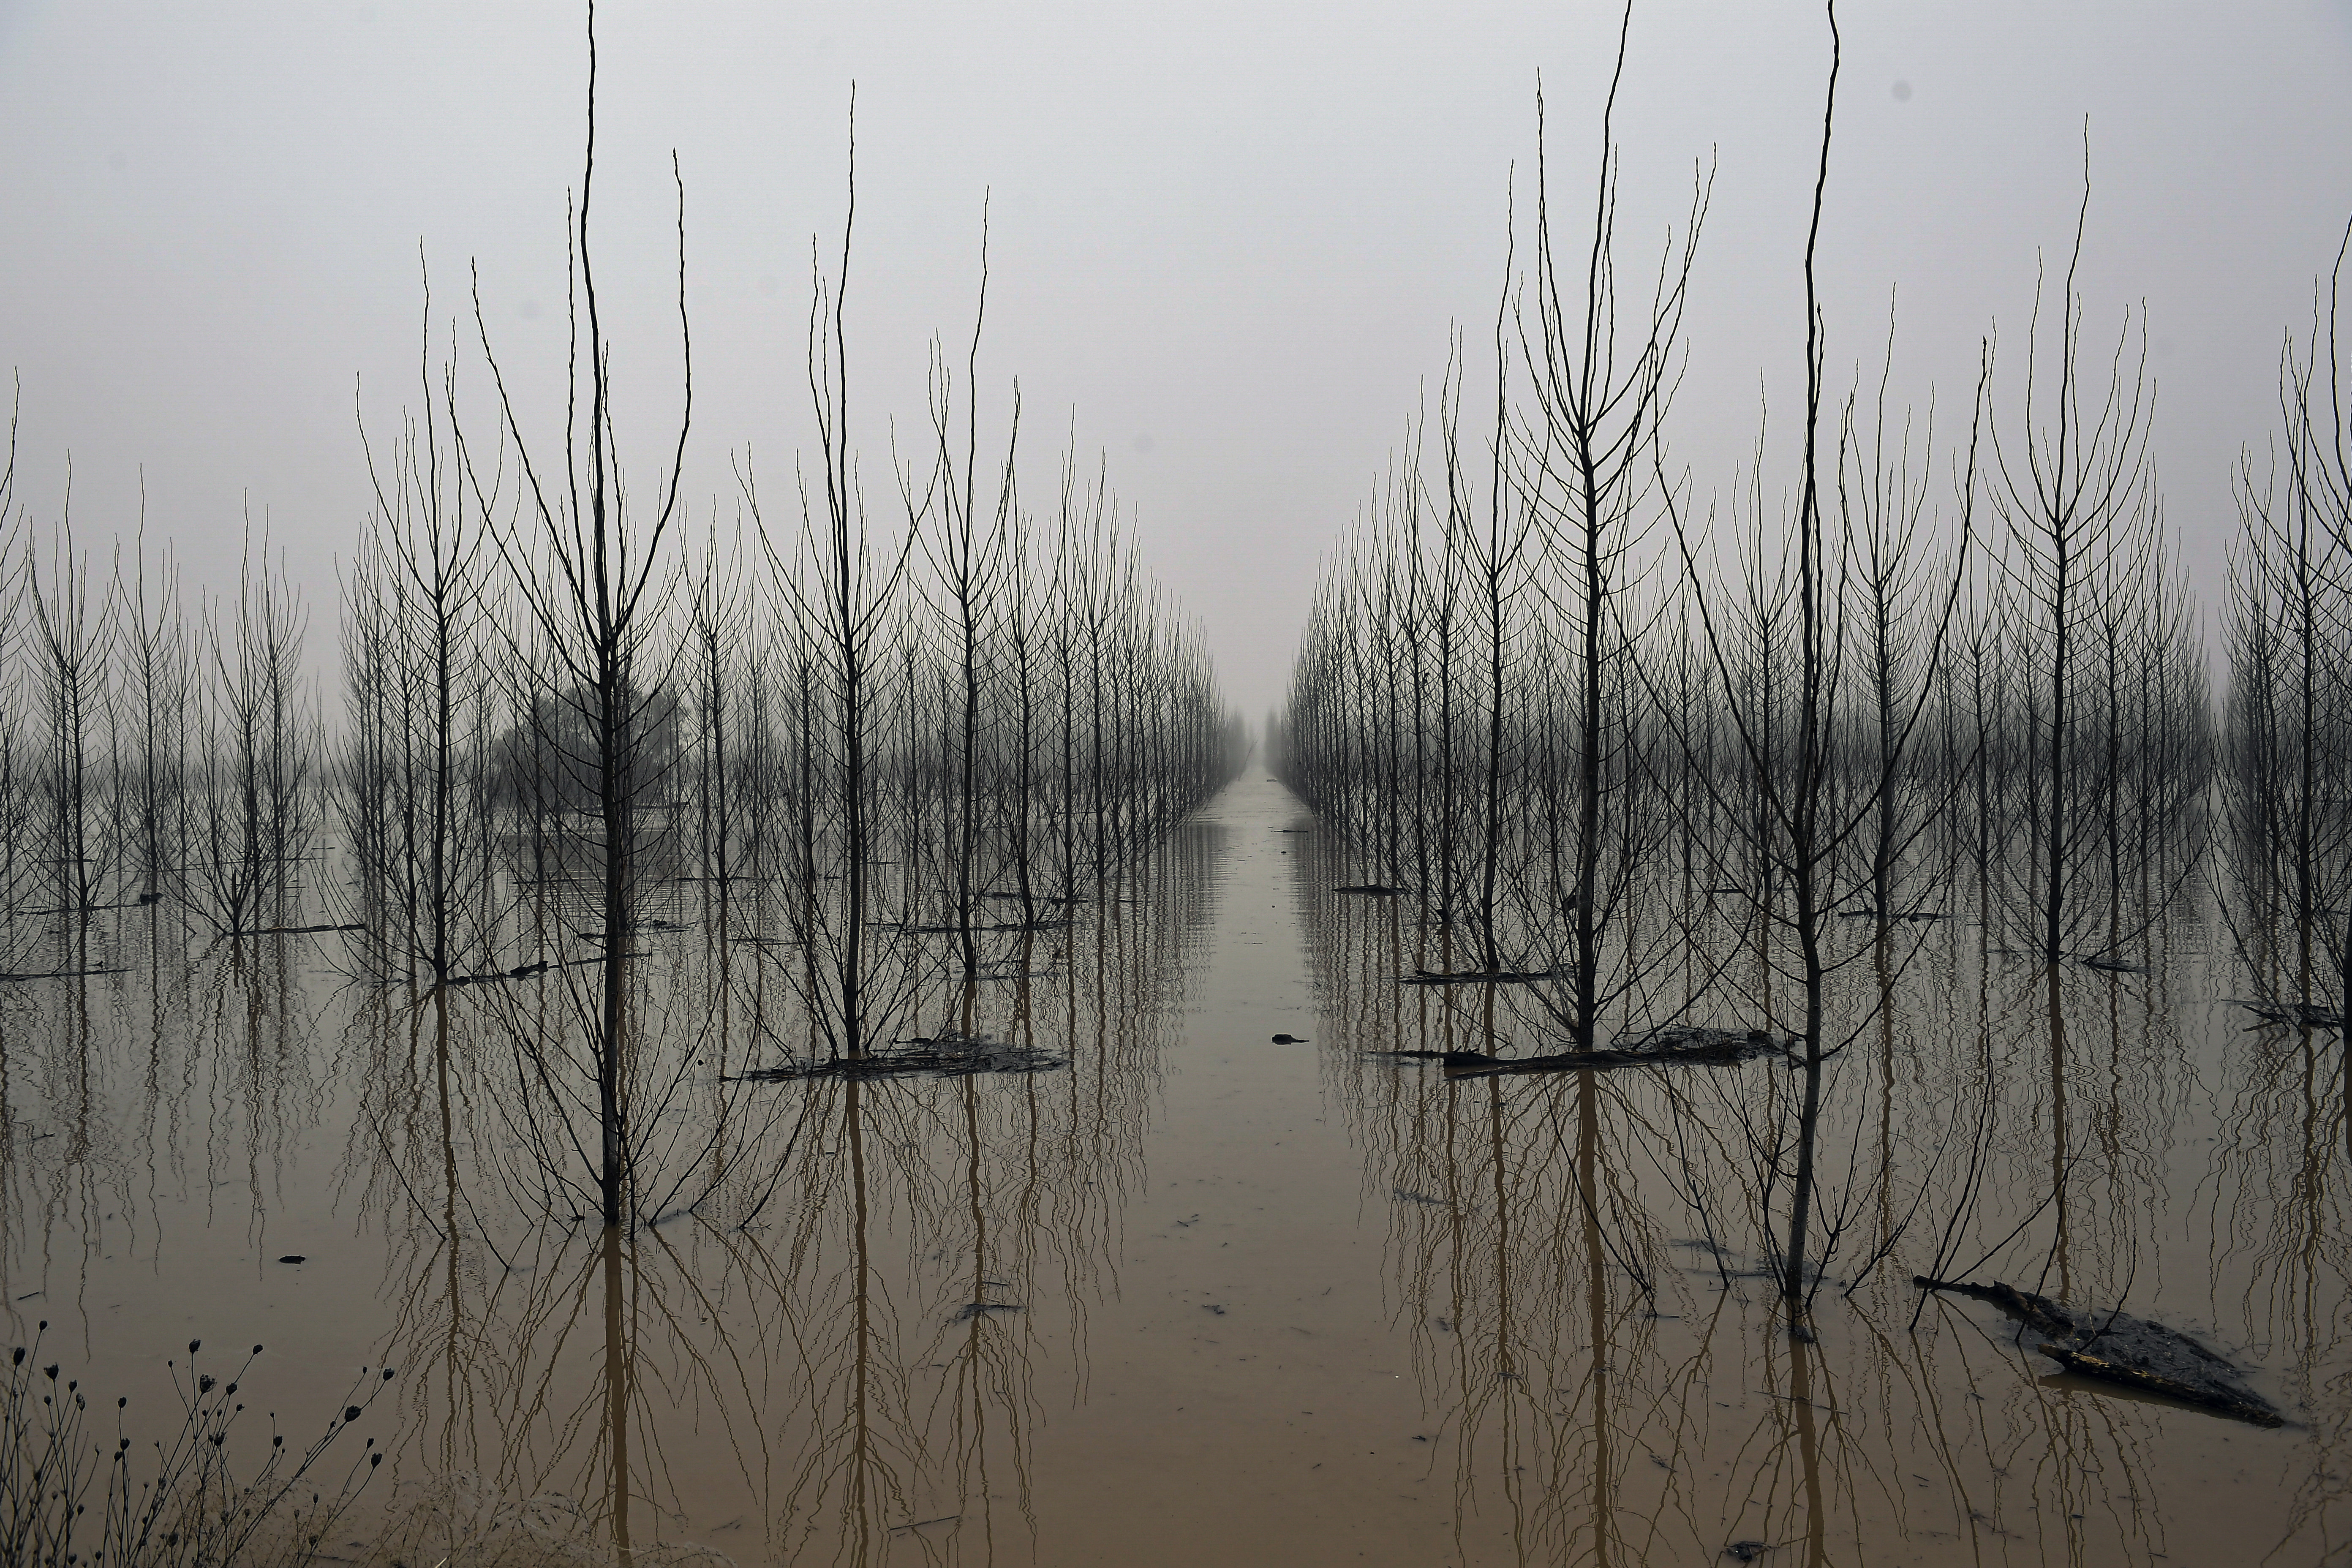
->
xmin=1270 ymin=7 xmax=2352 ymax=1298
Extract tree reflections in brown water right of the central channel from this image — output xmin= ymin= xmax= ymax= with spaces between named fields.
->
xmin=1303 ymin=804 xmax=2345 ymax=1563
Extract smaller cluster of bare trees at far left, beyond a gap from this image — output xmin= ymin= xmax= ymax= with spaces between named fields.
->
xmin=0 ymin=442 xmax=322 ymax=973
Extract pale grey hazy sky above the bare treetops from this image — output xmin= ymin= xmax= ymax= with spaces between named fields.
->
xmin=0 ymin=0 xmax=2352 ymax=715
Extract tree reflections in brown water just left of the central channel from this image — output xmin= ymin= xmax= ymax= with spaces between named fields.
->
xmin=289 ymin=835 xmax=1211 ymax=1563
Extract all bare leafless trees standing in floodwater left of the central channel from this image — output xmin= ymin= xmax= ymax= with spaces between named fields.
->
xmin=0 ymin=73 xmax=1244 ymax=1225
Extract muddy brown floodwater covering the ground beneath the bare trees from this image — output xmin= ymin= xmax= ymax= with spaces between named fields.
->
xmin=0 ymin=773 xmax=2352 ymax=1568
